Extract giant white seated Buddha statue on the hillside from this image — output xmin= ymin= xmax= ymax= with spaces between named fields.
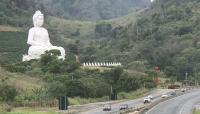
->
xmin=23 ymin=11 xmax=65 ymax=61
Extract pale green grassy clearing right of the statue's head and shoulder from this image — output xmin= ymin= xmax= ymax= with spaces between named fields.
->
xmin=47 ymin=16 xmax=95 ymax=44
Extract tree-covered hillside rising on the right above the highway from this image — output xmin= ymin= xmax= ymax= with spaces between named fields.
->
xmin=109 ymin=0 xmax=200 ymax=82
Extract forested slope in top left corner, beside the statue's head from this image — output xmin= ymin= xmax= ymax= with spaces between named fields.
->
xmin=0 ymin=0 xmax=33 ymax=27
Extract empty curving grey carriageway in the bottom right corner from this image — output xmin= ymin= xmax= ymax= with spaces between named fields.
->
xmin=145 ymin=90 xmax=200 ymax=114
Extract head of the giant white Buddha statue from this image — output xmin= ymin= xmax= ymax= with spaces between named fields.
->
xmin=33 ymin=10 xmax=44 ymax=27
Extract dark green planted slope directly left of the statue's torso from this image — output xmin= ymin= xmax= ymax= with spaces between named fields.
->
xmin=0 ymin=31 xmax=28 ymax=63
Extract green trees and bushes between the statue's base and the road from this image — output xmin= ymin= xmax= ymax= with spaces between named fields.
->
xmin=0 ymin=50 xmax=156 ymax=104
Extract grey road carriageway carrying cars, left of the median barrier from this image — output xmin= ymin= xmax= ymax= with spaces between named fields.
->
xmin=80 ymin=90 xmax=171 ymax=114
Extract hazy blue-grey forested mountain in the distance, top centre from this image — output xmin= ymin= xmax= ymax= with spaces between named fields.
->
xmin=40 ymin=0 xmax=150 ymax=20
